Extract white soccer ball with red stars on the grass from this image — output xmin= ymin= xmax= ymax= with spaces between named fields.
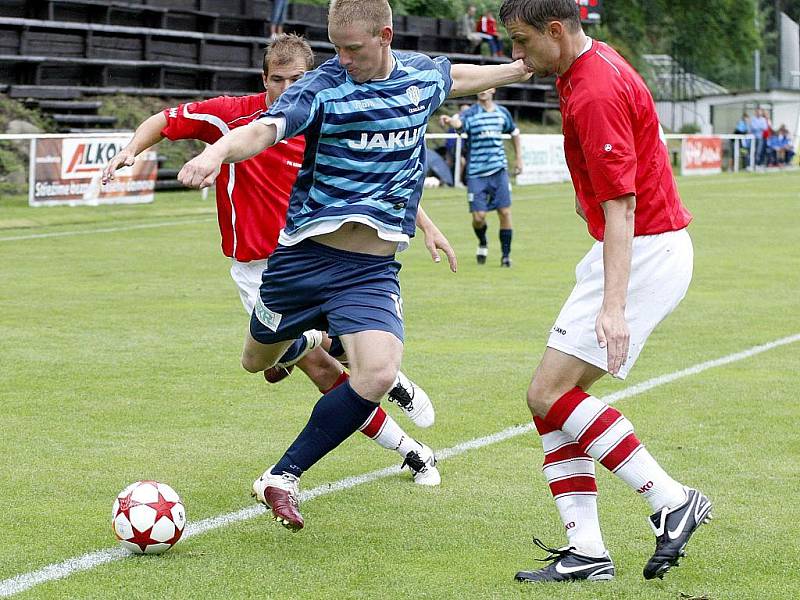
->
xmin=111 ymin=481 xmax=186 ymax=554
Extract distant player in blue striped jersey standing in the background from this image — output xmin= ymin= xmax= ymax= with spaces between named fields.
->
xmin=441 ymin=88 xmax=522 ymax=267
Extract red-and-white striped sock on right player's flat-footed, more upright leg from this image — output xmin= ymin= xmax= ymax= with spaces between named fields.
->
xmin=533 ymin=417 xmax=606 ymax=556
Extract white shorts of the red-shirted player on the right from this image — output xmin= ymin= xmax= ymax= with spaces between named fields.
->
xmin=547 ymin=229 xmax=694 ymax=379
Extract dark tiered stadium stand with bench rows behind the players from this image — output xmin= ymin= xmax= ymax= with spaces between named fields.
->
xmin=0 ymin=0 xmax=557 ymax=131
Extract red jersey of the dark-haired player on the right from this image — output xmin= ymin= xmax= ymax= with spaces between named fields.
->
xmin=556 ymin=41 xmax=692 ymax=241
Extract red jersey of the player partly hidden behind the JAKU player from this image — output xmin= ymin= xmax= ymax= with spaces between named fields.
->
xmin=161 ymin=92 xmax=306 ymax=262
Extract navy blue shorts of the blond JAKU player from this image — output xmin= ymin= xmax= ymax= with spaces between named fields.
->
xmin=250 ymin=240 xmax=403 ymax=344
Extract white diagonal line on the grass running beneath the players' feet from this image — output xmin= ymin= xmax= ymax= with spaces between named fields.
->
xmin=0 ymin=333 xmax=800 ymax=597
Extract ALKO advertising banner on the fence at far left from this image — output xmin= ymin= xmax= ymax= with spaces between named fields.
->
xmin=28 ymin=135 xmax=158 ymax=206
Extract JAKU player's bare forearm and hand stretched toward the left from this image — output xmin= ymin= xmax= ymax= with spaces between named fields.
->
xmin=178 ymin=121 xmax=277 ymax=189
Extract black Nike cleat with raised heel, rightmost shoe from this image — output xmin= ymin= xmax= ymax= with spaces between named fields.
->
xmin=643 ymin=487 xmax=712 ymax=579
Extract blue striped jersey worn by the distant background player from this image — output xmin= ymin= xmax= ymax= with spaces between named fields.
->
xmin=461 ymin=104 xmax=517 ymax=177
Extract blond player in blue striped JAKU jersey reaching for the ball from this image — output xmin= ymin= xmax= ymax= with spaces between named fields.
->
xmin=178 ymin=0 xmax=529 ymax=530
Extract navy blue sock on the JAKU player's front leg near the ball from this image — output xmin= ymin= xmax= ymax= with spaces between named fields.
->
xmin=272 ymin=380 xmax=379 ymax=477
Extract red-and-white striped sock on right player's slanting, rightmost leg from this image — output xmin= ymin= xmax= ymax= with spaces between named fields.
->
xmin=545 ymin=387 xmax=686 ymax=512
